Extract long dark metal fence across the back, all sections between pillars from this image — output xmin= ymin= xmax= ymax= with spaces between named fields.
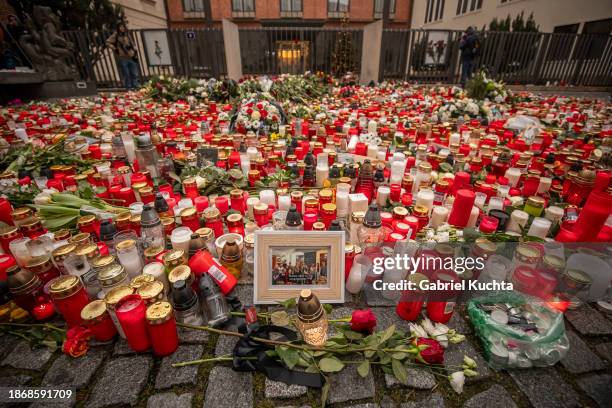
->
xmin=56 ymin=27 xmax=612 ymax=89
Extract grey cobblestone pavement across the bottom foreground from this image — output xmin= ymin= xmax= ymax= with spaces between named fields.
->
xmin=0 ymin=283 xmax=612 ymax=408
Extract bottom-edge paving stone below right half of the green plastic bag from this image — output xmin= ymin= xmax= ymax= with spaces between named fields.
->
xmin=509 ymin=368 xmax=580 ymax=408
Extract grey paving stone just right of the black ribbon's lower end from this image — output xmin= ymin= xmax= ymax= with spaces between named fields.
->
xmin=328 ymin=358 xmax=375 ymax=404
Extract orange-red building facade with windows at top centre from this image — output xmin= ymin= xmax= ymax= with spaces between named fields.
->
xmin=166 ymin=0 xmax=413 ymax=28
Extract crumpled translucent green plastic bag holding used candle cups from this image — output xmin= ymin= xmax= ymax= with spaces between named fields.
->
xmin=468 ymin=292 xmax=569 ymax=370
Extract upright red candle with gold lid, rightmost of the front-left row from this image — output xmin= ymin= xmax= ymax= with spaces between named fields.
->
xmin=146 ymin=302 xmax=178 ymax=357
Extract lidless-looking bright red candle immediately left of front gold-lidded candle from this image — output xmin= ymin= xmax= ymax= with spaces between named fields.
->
xmin=115 ymin=295 xmax=151 ymax=352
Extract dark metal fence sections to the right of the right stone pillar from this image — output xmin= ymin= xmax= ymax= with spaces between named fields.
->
xmin=380 ymin=29 xmax=612 ymax=86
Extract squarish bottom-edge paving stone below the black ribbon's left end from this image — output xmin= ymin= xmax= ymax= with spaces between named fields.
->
xmin=204 ymin=366 xmax=253 ymax=408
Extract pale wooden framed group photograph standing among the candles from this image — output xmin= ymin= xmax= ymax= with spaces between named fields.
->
xmin=253 ymin=231 xmax=345 ymax=305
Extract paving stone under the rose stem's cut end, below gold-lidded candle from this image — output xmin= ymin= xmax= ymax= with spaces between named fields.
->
xmin=155 ymin=345 xmax=204 ymax=390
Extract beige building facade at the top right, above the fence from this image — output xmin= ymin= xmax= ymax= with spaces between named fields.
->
xmin=412 ymin=0 xmax=612 ymax=34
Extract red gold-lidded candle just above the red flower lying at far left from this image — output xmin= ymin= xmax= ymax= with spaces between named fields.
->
xmin=49 ymin=275 xmax=89 ymax=327
